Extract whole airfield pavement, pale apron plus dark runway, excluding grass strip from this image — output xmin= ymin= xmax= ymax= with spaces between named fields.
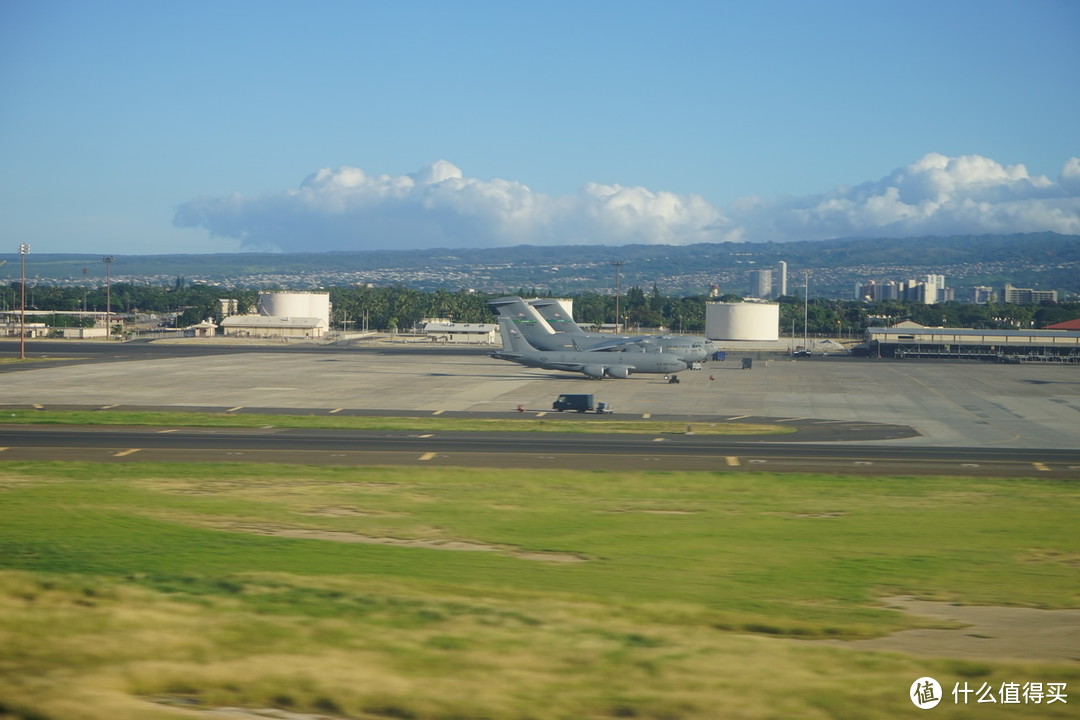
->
xmin=0 ymin=341 xmax=1080 ymax=477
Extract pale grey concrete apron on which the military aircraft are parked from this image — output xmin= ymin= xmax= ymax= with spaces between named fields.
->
xmin=0 ymin=342 xmax=1080 ymax=449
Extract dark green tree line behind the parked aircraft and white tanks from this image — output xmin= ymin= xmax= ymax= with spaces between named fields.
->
xmin=0 ymin=279 xmax=1080 ymax=336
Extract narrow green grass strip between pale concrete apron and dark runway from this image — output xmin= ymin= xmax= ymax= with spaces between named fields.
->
xmin=0 ymin=410 xmax=795 ymax=435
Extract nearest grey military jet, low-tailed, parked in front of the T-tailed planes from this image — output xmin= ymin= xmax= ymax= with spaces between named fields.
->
xmin=491 ymin=317 xmax=687 ymax=380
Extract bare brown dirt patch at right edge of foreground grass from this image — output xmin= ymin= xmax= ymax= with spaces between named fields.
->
xmin=811 ymin=597 xmax=1080 ymax=662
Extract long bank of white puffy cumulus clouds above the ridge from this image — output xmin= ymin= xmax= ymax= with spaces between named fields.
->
xmin=174 ymin=153 xmax=1080 ymax=252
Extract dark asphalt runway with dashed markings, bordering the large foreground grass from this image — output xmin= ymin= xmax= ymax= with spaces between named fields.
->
xmin=0 ymin=425 xmax=1080 ymax=478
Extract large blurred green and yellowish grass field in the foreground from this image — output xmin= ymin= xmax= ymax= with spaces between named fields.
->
xmin=0 ymin=463 xmax=1080 ymax=720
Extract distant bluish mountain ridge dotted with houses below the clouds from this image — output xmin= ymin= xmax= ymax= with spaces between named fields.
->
xmin=0 ymin=232 xmax=1080 ymax=297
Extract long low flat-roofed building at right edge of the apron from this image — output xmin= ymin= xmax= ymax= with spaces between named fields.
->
xmin=866 ymin=327 xmax=1080 ymax=363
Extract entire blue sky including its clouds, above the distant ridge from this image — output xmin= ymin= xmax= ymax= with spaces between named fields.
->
xmin=0 ymin=0 xmax=1080 ymax=254
